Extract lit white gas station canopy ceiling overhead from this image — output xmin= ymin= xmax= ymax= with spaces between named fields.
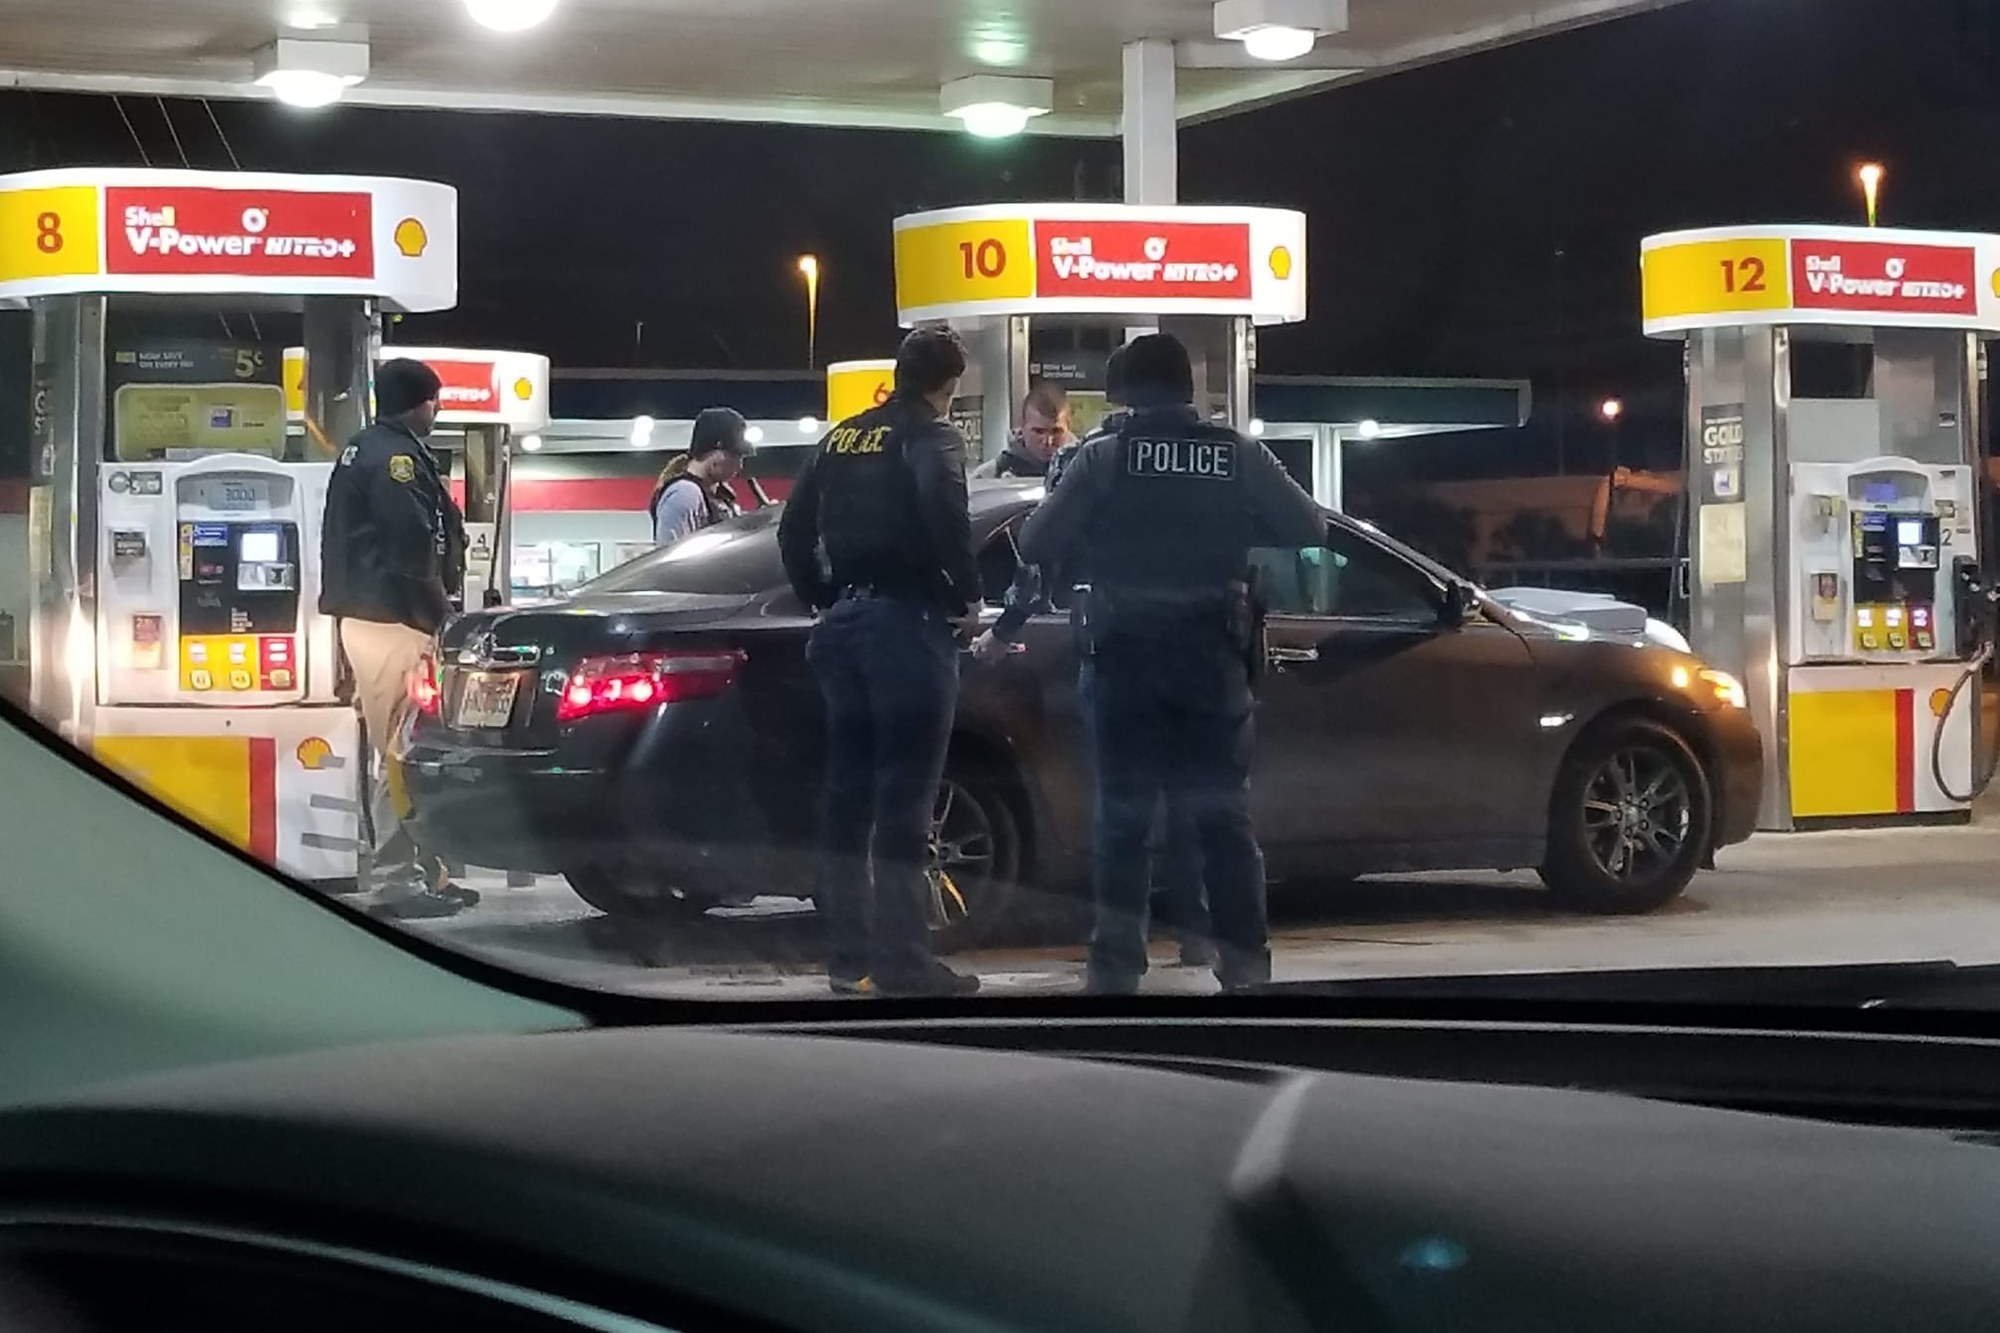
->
xmin=0 ymin=0 xmax=1674 ymax=136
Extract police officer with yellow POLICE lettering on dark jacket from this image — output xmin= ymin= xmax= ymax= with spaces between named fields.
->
xmin=778 ymin=328 xmax=980 ymax=995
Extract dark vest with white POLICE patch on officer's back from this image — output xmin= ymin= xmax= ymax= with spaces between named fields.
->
xmin=1084 ymin=410 xmax=1254 ymax=602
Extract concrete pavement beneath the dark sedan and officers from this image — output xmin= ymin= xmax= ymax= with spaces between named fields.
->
xmin=402 ymin=803 xmax=2000 ymax=999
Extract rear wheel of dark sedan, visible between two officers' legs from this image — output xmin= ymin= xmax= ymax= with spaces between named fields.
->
xmin=924 ymin=755 xmax=1024 ymax=953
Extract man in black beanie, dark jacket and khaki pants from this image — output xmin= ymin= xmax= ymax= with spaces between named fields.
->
xmin=320 ymin=360 xmax=478 ymax=921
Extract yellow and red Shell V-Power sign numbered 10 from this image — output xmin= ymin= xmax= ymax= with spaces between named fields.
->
xmin=896 ymin=204 xmax=1306 ymax=324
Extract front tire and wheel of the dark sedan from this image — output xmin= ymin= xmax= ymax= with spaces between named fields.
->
xmin=1540 ymin=717 xmax=1714 ymax=915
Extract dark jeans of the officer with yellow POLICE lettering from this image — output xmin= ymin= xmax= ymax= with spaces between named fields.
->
xmin=806 ymin=596 xmax=958 ymax=985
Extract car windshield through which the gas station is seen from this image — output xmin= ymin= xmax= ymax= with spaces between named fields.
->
xmin=0 ymin=0 xmax=2000 ymax=1015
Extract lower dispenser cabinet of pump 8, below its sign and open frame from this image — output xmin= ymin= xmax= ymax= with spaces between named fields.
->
xmin=92 ymin=452 xmax=358 ymax=879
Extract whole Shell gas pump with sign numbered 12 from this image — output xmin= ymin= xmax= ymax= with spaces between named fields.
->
xmin=1642 ymin=226 xmax=2000 ymax=831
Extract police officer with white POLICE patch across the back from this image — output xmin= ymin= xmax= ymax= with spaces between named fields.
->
xmin=1020 ymin=334 xmax=1326 ymax=995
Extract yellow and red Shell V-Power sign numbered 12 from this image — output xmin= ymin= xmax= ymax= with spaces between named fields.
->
xmin=1640 ymin=226 xmax=2000 ymax=336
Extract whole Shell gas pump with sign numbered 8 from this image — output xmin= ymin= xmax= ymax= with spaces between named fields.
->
xmin=0 ymin=168 xmax=458 ymax=881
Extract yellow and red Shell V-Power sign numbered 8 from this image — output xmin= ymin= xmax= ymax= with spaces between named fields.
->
xmin=0 ymin=168 xmax=458 ymax=312
